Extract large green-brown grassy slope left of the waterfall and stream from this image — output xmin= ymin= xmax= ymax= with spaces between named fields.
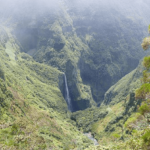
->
xmin=0 ymin=27 xmax=90 ymax=150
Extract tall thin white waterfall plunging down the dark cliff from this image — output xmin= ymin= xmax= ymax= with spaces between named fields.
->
xmin=64 ymin=73 xmax=72 ymax=111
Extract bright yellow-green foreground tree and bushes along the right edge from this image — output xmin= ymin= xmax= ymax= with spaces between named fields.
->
xmin=110 ymin=26 xmax=150 ymax=150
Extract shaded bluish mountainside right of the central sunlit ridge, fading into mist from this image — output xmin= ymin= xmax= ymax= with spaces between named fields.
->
xmin=65 ymin=0 xmax=148 ymax=102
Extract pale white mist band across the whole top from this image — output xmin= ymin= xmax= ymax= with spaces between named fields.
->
xmin=0 ymin=0 xmax=150 ymax=20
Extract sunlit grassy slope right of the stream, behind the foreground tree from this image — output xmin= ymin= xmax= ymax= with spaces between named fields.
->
xmin=72 ymin=61 xmax=143 ymax=149
